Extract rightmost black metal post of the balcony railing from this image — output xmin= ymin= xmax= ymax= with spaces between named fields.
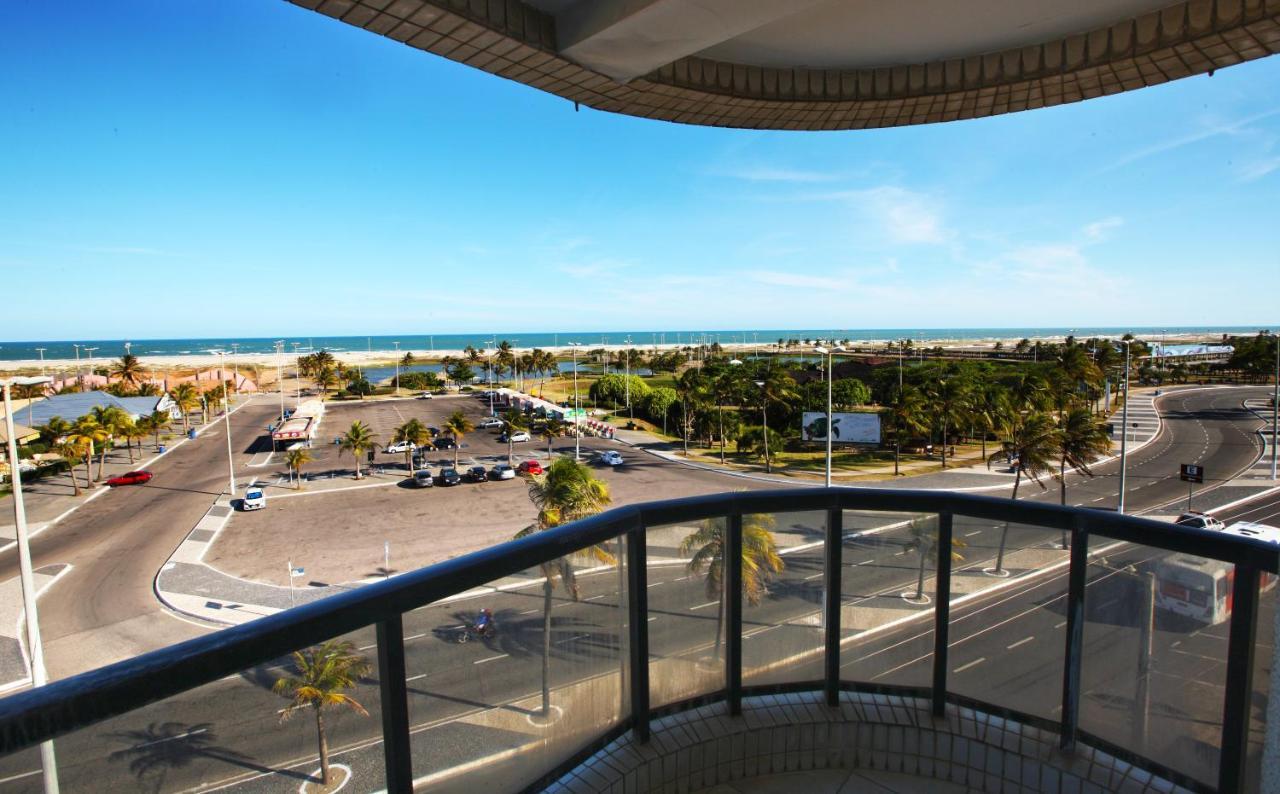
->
xmin=1217 ymin=565 xmax=1260 ymax=794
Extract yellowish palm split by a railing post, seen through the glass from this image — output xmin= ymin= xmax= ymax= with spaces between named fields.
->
xmin=680 ymin=514 xmax=785 ymax=660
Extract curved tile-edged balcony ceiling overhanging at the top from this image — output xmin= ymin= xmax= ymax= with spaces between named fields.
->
xmin=293 ymin=0 xmax=1280 ymax=129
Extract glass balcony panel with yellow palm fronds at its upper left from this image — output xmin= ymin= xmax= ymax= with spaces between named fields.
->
xmin=742 ymin=511 xmax=827 ymax=686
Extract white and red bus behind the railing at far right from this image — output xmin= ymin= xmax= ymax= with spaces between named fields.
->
xmin=1156 ymin=521 xmax=1280 ymax=625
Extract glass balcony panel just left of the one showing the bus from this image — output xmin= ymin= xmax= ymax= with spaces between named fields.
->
xmin=947 ymin=516 xmax=1068 ymax=721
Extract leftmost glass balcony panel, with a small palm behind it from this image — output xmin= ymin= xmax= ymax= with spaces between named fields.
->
xmin=30 ymin=628 xmax=385 ymax=791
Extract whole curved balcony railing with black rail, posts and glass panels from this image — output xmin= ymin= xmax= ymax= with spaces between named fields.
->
xmin=0 ymin=488 xmax=1280 ymax=793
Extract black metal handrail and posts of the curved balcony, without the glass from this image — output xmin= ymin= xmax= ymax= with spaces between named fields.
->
xmin=0 ymin=488 xmax=1280 ymax=791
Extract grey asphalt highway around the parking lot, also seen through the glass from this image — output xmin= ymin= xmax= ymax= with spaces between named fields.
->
xmin=0 ymin=389 xmax=1280 ymax=790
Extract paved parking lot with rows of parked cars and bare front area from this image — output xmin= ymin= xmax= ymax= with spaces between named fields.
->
xmin=205 ymin=397 xmax=763 ymax=585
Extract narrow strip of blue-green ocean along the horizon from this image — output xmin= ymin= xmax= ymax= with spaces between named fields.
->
xmin=0 ymin=325 xmax=1261 ymax=361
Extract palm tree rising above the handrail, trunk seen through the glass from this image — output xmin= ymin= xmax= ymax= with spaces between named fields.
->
xmin=509 ymin=455 xmax=617 ymax=716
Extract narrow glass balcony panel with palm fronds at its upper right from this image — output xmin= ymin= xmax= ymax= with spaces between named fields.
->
xmin=646 ymin=519 xmax=728 ymax=708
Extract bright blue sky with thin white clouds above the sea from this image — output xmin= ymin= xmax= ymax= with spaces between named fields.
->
xmin=0 ymin=0 xmax=1280 ymax=339
